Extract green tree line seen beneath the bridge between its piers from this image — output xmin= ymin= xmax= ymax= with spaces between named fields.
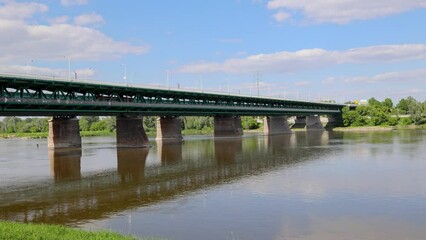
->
xmin=0 ymin=116 xmax=262 ymax=134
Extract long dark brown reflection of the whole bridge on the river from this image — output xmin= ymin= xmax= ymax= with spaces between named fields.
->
xmin=0 ymin=132 xmax=331 ymax=225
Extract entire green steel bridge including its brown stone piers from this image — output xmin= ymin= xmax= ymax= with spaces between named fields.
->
xmin=0 ymin=74 xmax=345 ymax=148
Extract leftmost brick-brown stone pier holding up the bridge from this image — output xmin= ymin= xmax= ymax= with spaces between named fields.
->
xmin=47 ymin=116 xmax=81 ymax=149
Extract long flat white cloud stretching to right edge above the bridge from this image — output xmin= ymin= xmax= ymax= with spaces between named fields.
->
xmin=179 ymin=44 xmax=426 ymax=73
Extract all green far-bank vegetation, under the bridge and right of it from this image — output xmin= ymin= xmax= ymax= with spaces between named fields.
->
xmin=0 ymin=97 xmax=426 ymax=139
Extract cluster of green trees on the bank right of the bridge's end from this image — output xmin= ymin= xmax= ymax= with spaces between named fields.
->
xmin=342 ymin=97 xmax=426 ymax=127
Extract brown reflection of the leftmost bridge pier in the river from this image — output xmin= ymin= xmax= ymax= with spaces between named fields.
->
xmin=49 ymin=148 xmax=81 ymax=182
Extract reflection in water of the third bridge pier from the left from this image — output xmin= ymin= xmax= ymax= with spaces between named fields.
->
xmin=157 ymin=140 xmax=183 ymax=166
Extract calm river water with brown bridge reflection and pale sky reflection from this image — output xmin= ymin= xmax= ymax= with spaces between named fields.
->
xmin=0 ymin=130 xmax=426 ymax=240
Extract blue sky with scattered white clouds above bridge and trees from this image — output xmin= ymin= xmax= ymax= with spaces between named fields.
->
xmin=0 ymin=0 xmax=426 ymax=102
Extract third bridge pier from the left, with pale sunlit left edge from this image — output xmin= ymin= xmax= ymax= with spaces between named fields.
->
xmin=157 ymin=117 xmax=182 ymax=140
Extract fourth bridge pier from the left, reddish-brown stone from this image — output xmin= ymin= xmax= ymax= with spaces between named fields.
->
xmin=214 ymin=116 xmax=243 ymax=137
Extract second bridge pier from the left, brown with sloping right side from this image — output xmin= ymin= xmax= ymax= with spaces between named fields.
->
xmin=117 ymin=116 xmax=149 ymax=148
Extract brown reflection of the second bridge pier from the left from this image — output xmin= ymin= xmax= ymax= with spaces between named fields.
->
xmin=117 ymin=148 xmax=149 ymax=183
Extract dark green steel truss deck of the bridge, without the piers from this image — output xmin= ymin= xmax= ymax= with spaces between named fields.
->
xmin=0 ymin=74 xmax=345 ymax=116
